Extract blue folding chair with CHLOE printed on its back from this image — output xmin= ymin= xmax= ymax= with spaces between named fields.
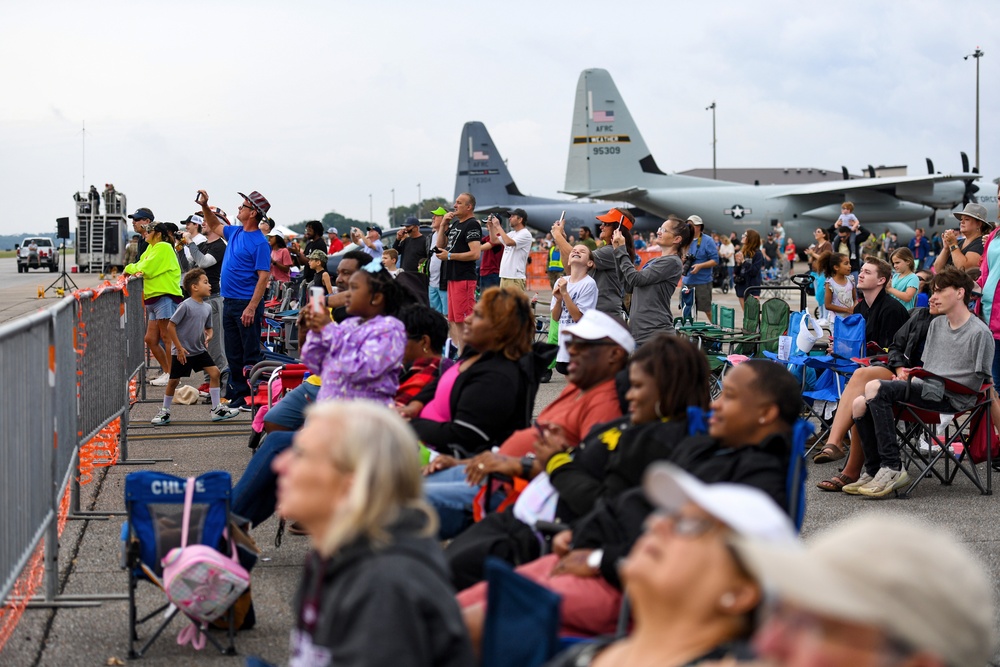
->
xmin=122 ymin=470 xmax=236 ymax=659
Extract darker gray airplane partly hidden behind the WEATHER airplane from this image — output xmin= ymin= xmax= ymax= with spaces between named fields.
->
xmin=455 ymin=121 xmax=663 ymax=234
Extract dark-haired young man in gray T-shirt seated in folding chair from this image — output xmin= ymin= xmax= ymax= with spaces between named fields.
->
xmin=844 ymin=266 xmax=995 ymax=498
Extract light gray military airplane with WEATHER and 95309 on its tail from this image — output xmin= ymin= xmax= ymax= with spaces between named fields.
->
xmin=564 ymin=69 xmax=980 ymax=245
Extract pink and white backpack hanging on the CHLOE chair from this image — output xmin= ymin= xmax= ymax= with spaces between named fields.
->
xmin=163 ymin=477 xmax=250 ymax=649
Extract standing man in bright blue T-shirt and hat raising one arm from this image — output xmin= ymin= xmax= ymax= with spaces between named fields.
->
xmin=197 ymin=185 xmax=271 ymax=412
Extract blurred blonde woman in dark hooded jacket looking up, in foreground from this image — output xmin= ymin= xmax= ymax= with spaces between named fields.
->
xmin=273 ymin=401 xmax=475 ymax=667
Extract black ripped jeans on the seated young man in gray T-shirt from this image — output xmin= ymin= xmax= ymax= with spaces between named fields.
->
xmin=854 ymin=380 xmax=955 ymax=477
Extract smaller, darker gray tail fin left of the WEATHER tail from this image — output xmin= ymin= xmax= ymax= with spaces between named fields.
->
xmin=455 ymin=121 xmax=524 ymax=205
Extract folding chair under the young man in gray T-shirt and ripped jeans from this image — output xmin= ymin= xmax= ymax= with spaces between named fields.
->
xmin=893 ymin=368 xmax=997 ymax=498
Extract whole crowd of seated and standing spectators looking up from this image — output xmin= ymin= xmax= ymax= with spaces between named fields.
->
xmin=125 ymin=190 xmax=1000 ymax=666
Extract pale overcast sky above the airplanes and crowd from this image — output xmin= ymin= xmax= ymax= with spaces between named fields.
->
xmin=0 ymin=0 xmax=1000 ymax=234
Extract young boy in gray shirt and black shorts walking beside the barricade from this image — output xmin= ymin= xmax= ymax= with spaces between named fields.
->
xmin=150 ymin=269 xmax=240 ymax=426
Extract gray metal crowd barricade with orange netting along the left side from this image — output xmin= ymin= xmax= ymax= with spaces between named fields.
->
xmin=0 ymin=279 xmax=153 ymax=648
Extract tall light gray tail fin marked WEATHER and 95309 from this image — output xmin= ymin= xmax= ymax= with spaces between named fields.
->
xmin=565 ymin=69 xmax=680 ymax=195
